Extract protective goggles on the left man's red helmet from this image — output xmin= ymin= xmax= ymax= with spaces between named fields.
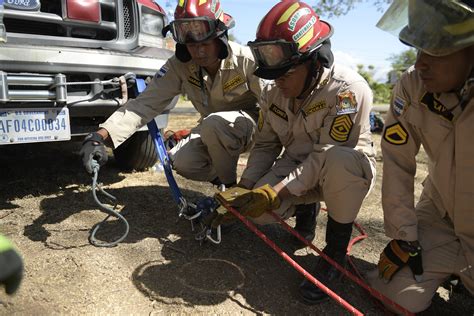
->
xmin=170 ymin=17 xmax=217 ymax=44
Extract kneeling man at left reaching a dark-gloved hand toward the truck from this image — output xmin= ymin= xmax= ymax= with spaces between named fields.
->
xmin=82 ymin=0 xmax=263 ymax=186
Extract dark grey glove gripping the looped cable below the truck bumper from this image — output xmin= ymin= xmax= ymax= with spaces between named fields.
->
xmin=80 ymin=133 xmax=108 ymax=174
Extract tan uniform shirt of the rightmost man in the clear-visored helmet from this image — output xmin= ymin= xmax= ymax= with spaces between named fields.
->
xmin=382 ymin=68 xmax=474 ymax=273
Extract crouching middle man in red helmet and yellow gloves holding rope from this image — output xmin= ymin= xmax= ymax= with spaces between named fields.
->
xmin=216 ymin=1 xmax=375 ymax=304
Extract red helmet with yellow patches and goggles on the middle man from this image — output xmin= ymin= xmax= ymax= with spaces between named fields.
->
xmin=248 ymin=0 xmax=334 ymax=79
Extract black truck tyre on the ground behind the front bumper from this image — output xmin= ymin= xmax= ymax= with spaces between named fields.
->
xmin=114 ymin=131 xmax=158 ymax=171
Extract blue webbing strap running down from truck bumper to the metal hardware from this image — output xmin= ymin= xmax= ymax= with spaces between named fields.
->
xmin=136 ymin=79 xmax=183 ymax=206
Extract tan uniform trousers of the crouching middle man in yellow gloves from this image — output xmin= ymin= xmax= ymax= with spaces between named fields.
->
xmin=252 ymin=146 xmax=375 ymax=224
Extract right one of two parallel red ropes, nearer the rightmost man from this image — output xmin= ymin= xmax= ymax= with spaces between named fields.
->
xmin=270 ymin=210 xmax=415 ymax=316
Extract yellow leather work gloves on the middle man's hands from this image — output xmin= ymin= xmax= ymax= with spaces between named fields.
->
xmin=215 ymin=184 xmax=280 ymax=218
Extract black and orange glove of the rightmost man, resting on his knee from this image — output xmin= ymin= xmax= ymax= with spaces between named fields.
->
xmin=377 ymin=239 xmax=423 ymax=282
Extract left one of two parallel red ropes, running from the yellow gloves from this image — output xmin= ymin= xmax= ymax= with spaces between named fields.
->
xmin=224 ymin=205 xmax=363 ymax=315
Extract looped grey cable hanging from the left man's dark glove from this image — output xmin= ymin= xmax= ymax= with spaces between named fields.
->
xmin=89 ymin=160 xmax=130 ymax=247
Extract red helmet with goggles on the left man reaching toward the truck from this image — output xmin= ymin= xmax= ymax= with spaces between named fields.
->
xmin=170 ymin=0 xmax=235 ymax=44
